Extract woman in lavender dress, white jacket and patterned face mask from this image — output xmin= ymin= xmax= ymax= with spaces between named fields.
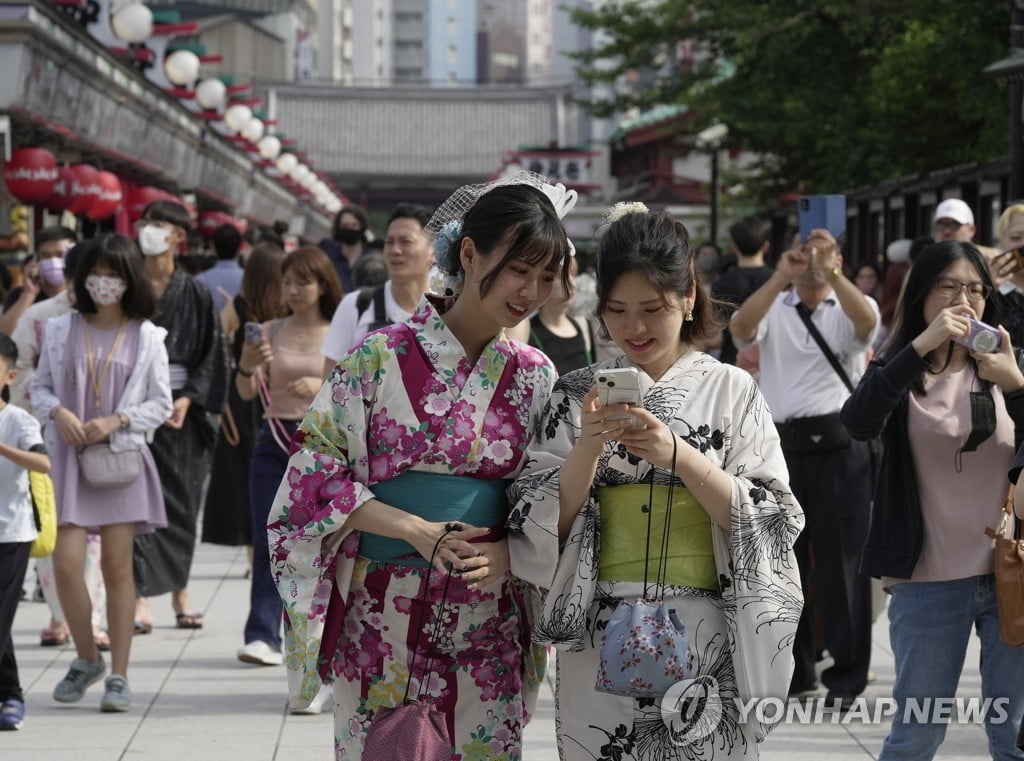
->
xmin=30 ymin=235 xmax=173 ymax=712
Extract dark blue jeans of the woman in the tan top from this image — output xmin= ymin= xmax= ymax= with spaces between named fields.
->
xmin=245 ymin=420 xmax=298 ymax=649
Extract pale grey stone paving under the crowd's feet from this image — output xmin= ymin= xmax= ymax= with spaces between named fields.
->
xmin=6 ymin=545 xmax=988 ymax=761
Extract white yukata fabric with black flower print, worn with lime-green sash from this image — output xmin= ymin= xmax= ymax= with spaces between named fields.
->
xmin=509 ymin=352 xmax=804 ymax=761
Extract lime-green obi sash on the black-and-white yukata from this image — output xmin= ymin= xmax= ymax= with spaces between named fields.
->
xmin=597 ymin=483 xmax=719 ymax=591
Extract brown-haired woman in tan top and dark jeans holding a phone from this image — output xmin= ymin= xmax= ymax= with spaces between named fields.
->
xmin=234 ymin=246 xmax=341 ymax=666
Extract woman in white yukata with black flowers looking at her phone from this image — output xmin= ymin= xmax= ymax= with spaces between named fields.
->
xmin=509 ymin=204 xmax=804 ymax=761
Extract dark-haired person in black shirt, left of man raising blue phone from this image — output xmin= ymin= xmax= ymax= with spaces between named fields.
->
xmin=711 ymin=216 xmax=772 ymax=365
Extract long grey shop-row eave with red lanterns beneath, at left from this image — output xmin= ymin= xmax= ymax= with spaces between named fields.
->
xmin=0 ymin=0 xmax=330 ymax=257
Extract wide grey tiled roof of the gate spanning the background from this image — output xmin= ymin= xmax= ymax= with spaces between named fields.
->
xmin=274 ymin=86 xmax=579 ymax=180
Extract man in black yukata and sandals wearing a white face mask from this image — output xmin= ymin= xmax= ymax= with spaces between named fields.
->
xmin=135 ymin=201 xmax=227 ymax=634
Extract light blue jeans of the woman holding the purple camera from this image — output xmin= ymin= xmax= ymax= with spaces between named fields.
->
xmin=879 ymin=574 xmax=1024 ymax=761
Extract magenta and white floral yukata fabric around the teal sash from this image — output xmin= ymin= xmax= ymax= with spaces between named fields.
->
xmin=268 ymin=301 xmax=555 ymax=759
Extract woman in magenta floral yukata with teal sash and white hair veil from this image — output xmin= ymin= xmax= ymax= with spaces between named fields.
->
xmin=268 ymin=173 xmax=575 ymax=761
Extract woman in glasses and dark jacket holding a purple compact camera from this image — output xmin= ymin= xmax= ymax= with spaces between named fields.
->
xmin=842 ymin=241 xmax=1024 ymax=761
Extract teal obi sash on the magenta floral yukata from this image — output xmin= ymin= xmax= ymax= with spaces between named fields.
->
xmin=359 ymin=470 xmax=508 ymax=568
